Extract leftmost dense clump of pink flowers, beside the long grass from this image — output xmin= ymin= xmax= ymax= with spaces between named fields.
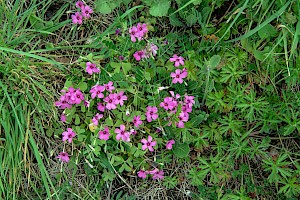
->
xmin=55 ymin=87 xmax=84 ymax=109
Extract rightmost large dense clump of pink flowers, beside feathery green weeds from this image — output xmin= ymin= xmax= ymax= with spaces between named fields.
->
xmin=159 ymin=91 xmax=195 ymax=128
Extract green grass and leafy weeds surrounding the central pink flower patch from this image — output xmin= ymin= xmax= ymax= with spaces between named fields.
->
xmin=0 ymin=0 xmax=300 ymax=199
